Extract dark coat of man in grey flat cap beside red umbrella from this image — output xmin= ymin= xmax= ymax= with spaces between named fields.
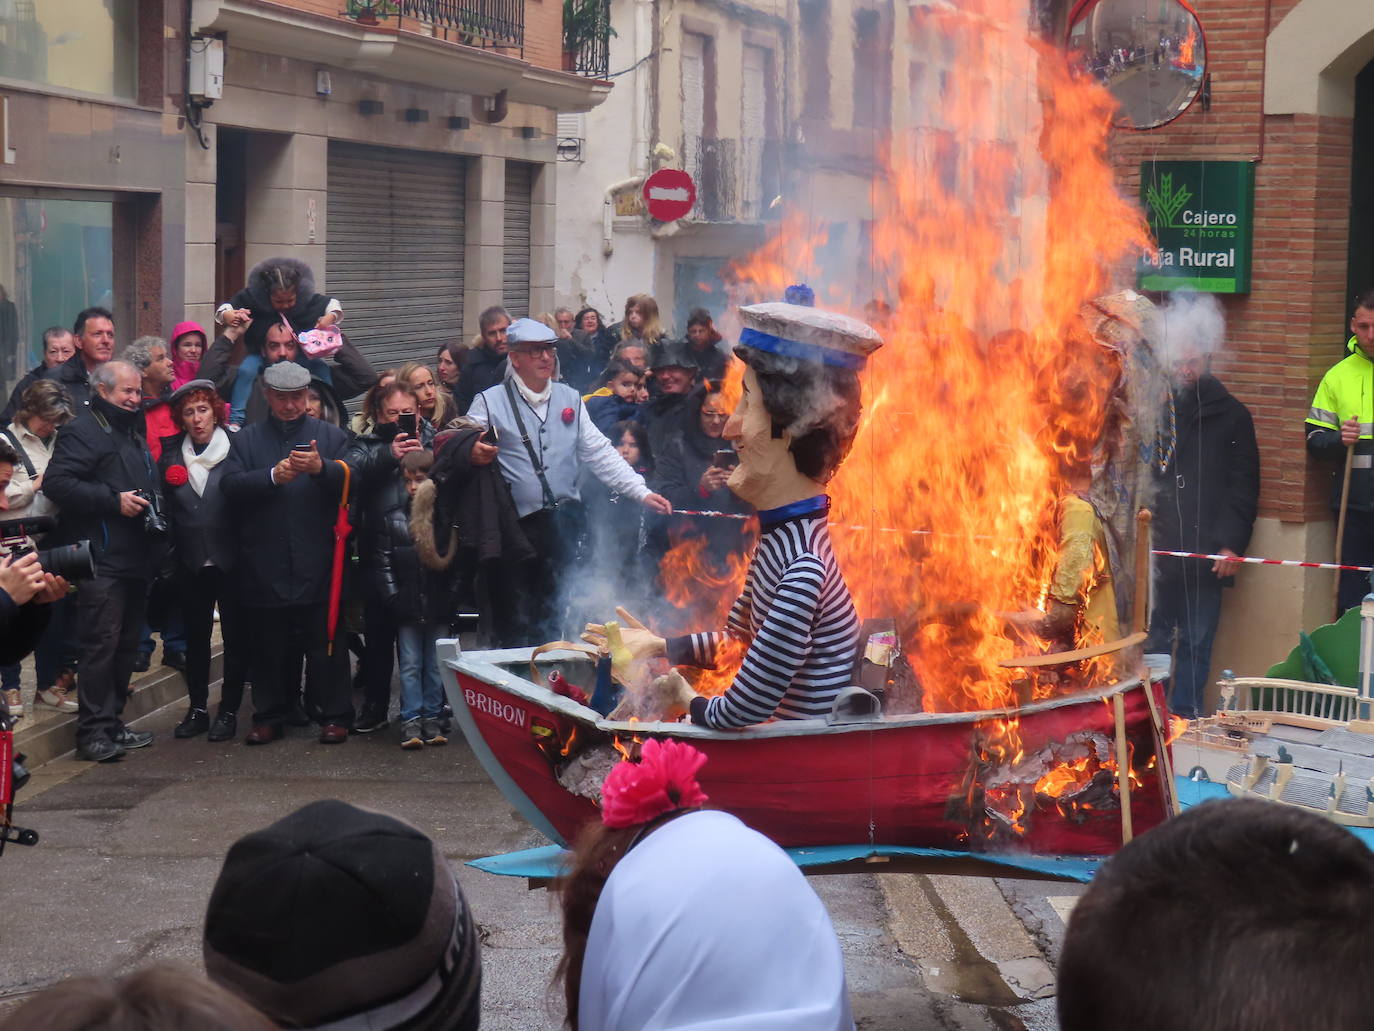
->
xmin=221 ymin=415 xmax=348 ymax=608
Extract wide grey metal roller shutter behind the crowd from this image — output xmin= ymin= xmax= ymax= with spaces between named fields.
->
xmin=324 ymin=142 xmax=466 ymax=371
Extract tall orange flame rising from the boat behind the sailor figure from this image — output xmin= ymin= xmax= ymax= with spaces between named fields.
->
xmin=734 ymin=0 xmax=1150 ymax=736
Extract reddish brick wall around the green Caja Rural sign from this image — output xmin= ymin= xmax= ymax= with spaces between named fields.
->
xmin=1112 ymin=0 xmax=1352 ymax=521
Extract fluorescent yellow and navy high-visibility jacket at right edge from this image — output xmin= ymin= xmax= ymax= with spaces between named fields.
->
xmin=1304 ymin=337 xmax=1374 ymax=511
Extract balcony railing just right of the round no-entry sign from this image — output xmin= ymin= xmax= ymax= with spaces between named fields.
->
xmin=684 ymin=136 xmax=782 ymax=223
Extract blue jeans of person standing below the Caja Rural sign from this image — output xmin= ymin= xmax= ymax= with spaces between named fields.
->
xmin=1146 ymin=558 xmax=1223 ymax=719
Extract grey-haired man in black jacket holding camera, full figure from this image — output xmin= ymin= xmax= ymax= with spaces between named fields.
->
xmin=43 ymin=362 xmax=169 ymax=763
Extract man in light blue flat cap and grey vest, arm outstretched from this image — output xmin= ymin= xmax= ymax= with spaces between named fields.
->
xmin=467 ymin=319 xmax=672 ymax=647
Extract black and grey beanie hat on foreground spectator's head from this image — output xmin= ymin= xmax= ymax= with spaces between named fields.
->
xmin=203 ymin=800 xmax=481 ymax=1031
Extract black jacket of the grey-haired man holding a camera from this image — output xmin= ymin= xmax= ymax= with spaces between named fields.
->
xmin=43 ymin=390 xmax=170 ymax=580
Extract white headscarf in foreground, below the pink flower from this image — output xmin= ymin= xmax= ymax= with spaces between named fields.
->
xmin=578 ymin=811 xmax=855 ymax=1031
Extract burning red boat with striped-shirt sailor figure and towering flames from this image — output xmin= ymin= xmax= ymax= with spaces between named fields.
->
xmin=436 ymin=0 xmax=1172 ymax=855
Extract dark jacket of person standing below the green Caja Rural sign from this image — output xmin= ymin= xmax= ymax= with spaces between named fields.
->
xmin=1153 ymin=375 xmax=1260 ymax=568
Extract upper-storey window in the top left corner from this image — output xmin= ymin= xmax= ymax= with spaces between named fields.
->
xmin=0 ymin=0 xmax=139 ymax=99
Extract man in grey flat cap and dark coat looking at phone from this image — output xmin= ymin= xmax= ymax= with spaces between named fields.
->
xmin=223 ymin=362 xmax=353 ymax=745
